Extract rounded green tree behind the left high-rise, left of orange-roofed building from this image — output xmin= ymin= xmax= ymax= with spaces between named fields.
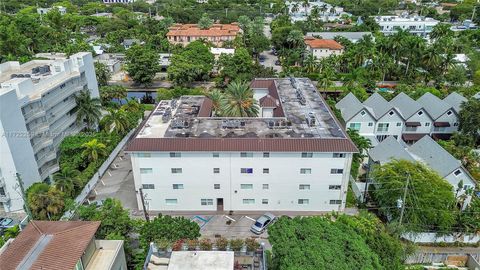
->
xmin=125 ymin=45 xmax=160 ymax=85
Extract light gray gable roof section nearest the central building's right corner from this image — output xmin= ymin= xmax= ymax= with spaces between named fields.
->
xmin=368 ymin=136 xmax=415 ymax=164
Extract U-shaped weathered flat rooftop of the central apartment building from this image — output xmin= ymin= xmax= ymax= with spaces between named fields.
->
xmin=137 ymin=79 xmax=346 ymax=138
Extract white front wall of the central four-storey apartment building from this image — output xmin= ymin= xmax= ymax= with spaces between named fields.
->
xmin=132 ymin=152 xmax=351 ymax=211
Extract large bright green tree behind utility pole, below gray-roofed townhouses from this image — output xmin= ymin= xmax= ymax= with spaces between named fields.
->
xmin=371 ymin=160 xmax=458 ymax=232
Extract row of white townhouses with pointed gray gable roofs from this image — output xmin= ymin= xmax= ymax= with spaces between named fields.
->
xmin=335 ymin=92 xmax=467 ymax=146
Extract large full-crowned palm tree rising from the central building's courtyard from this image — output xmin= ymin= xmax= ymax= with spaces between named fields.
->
xmin=221 ymin=82 xmax=259 ymax=117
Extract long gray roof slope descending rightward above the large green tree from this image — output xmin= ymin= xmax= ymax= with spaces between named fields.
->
xmin=408 ymin=136 xmax=462 ymax=177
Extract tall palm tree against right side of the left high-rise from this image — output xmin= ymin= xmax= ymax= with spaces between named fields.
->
xmin=75 ymin=90 xmax=102 ymax=129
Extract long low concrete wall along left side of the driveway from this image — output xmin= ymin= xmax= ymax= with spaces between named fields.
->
xmin=61 ymin=128 xmax=136 ymax=220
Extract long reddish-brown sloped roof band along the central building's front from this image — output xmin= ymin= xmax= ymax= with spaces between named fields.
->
xmin=126 ymin=138 xmax=358 ymax=153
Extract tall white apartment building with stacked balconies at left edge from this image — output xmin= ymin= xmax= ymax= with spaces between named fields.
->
xmin=0 ymin=53 xmax=99 ymax=212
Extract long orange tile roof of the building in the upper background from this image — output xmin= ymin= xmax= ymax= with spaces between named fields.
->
xmin=167 ymin=23 xmax=240 ymax=37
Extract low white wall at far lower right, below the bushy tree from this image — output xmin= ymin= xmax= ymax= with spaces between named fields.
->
xmin=402 ymin=233 xmax=480 ymax=244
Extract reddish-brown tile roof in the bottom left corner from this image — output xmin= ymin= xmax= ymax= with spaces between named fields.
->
xmin=0 ymin=220 xmax=100 ymax=270
